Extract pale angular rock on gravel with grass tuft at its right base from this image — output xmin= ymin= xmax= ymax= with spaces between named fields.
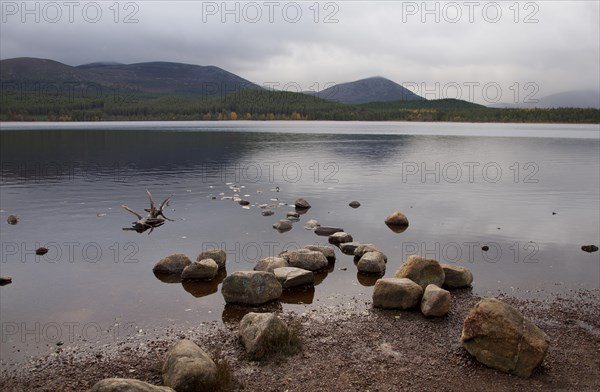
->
xmin=239 ymin=313 xmax=289 ymax=359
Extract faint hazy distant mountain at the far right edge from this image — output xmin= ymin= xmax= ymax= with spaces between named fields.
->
xmin=490 ymin=90 xmax=600 ymax=109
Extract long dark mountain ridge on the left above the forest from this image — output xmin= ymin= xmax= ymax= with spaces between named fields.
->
xmin=0 ymin=58 xmax=262 ymax=96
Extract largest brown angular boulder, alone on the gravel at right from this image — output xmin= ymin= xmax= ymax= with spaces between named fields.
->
xmin=461 ymin=298 xmax=549 ymax=378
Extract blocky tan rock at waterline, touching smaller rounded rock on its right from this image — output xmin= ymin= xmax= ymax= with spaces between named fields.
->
xmin=373 ymin=278 xmax=423 ymax=310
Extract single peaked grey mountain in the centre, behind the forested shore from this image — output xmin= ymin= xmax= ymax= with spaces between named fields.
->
xmin=313 ymin=76 xmax=424 ymax=104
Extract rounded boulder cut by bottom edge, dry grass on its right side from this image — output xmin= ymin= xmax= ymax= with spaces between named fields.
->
xmin=162 ymin=339 xmax=217 ymax=392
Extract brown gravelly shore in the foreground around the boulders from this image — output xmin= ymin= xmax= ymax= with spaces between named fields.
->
xmin=0 ymin=289 xmax=600 ymax=392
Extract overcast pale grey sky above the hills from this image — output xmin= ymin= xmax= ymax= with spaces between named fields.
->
xmin=0 ymin=0 xmax=600 ymax=103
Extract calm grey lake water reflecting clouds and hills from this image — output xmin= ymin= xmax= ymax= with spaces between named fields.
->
xmin=0 ymin=122 xmax=600 ymax=361
